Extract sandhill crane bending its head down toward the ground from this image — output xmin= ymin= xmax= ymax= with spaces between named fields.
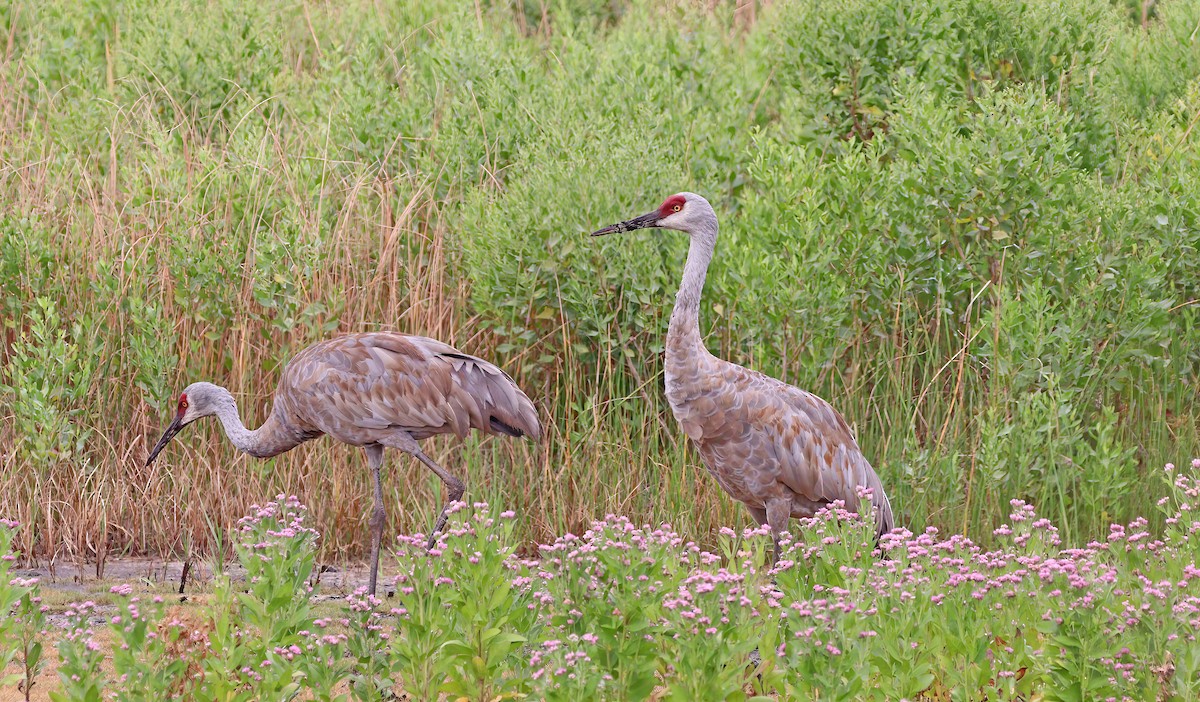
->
xmin=146 ymin=331 xmax=541 ymax=594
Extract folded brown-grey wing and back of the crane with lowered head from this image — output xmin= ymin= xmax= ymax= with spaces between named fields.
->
xmin=277 ymin=332 xmax=541 ymax=444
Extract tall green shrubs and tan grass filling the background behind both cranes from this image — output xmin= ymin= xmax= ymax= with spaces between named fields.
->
xmin=0 ymin=0 xmax=1200 ymax=560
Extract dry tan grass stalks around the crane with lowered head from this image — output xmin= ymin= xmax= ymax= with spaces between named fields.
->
xmin=0 ymin=61 xmax=728 ymax=564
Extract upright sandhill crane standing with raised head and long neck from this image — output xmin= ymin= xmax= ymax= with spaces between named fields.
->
xmin=592 ymin=192 xmax=893 ymax=560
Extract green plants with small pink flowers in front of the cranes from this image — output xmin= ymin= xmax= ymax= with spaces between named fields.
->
xmin=21 ymin=470 xmax=1200 ymax=702
